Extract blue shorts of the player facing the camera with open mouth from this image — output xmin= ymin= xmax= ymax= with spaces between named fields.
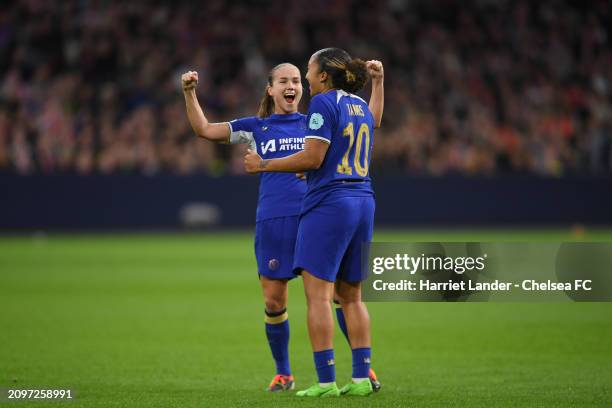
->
xmin=255 ymin=215 xmax=299 ymax=279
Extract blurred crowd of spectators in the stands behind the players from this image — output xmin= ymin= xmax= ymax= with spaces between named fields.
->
xmin=0 ymin=0 xmax=612 ymax=176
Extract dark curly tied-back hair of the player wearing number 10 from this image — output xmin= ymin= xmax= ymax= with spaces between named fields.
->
xmin=314 ymin=48 xmax=370 ymax=93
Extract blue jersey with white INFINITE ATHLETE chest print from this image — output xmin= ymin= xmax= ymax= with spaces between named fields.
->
xmin=229 ymin=113 xmax=306 ymax=221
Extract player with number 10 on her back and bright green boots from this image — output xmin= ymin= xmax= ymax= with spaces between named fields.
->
xmin=245 ymin=48 xmax=383 ymax=397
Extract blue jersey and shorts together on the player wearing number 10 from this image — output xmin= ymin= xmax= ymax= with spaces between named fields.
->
xmin=293 ymin=90 xmax=376 ymax=282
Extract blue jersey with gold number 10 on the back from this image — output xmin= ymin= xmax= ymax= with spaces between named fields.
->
xmin=302 ymin=90 xmax=374 ymax=213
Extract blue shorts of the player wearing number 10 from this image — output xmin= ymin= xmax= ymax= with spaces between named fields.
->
xmin=293 ymin=196 xmax=375 ymax=282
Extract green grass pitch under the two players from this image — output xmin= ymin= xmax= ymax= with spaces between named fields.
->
xmin=0 ymin=229 xmax=612 ymax=408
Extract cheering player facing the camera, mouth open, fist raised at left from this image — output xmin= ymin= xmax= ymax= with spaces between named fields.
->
xmin=182 ymin=63 xmax=383 ymax=391
